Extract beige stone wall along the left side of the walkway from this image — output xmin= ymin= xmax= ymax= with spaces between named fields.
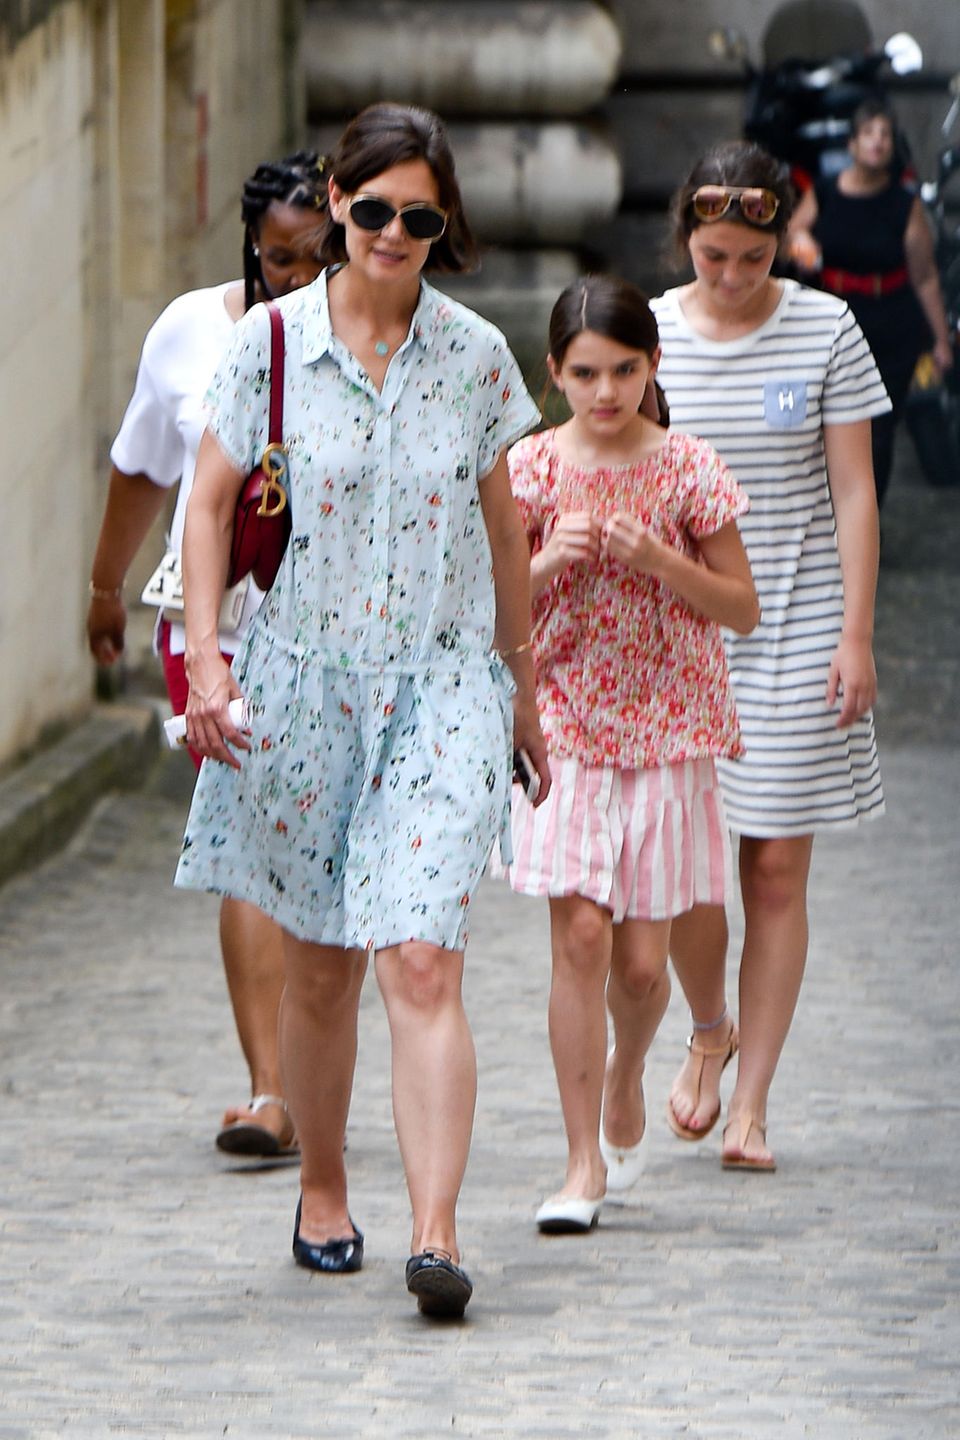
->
xmin=0 ymin=0 xmax=302 ymax=765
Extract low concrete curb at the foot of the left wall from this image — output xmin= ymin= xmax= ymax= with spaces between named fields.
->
xmin=0 ymin=701 xmax=161 ymax=886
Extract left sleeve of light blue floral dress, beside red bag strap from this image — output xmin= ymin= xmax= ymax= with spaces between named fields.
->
xmin=203 ymin=305 xmax=271 ymax=472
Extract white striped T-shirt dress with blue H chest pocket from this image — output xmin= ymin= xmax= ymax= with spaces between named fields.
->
xmin=653 ymin=281 xmax=889 ymax=838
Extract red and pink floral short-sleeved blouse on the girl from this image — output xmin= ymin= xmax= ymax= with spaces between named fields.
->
xmin=510 ymin=431 xmax=748 ymax=769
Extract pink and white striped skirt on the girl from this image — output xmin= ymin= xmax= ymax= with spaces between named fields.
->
xmin=507 ymin=757 xmax=733 ymax=922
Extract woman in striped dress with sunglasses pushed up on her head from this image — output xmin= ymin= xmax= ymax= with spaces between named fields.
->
xmin=653 ymin=143 xmax=889 ymax=1171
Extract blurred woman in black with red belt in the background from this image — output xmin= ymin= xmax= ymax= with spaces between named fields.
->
xmin=790 ymin=101 xmax=953 ymax=503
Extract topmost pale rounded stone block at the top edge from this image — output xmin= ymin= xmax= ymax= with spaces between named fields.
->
xmin=304 ymin=0 xmax=620 ymax=118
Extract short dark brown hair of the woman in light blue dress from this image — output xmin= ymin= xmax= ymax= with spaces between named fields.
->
xmin=314 ymin=102 xmax=478 ymax=274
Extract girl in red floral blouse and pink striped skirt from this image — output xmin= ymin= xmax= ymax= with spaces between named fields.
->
xmin=508 ymin=276 xmax=759 ymax=1233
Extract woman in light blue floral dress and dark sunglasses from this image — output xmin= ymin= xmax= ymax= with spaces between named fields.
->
xmin=177 ymin=104 xmax=550 ymax=1316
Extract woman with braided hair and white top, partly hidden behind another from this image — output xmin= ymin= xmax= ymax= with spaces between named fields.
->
xmin=86 ymin=153 xmax=327 ymax=1156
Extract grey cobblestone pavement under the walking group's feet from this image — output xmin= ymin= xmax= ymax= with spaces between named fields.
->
xmin=0 ymin=457 xmax=960 ymax=1440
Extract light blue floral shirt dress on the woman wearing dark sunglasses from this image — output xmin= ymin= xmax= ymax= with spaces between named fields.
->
xmin=176 ymin=274 xmax=538 ymax=949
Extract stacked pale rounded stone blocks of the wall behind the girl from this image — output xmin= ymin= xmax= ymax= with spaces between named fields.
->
xmin=304 ymin=0 xmax=622 ymax=373
